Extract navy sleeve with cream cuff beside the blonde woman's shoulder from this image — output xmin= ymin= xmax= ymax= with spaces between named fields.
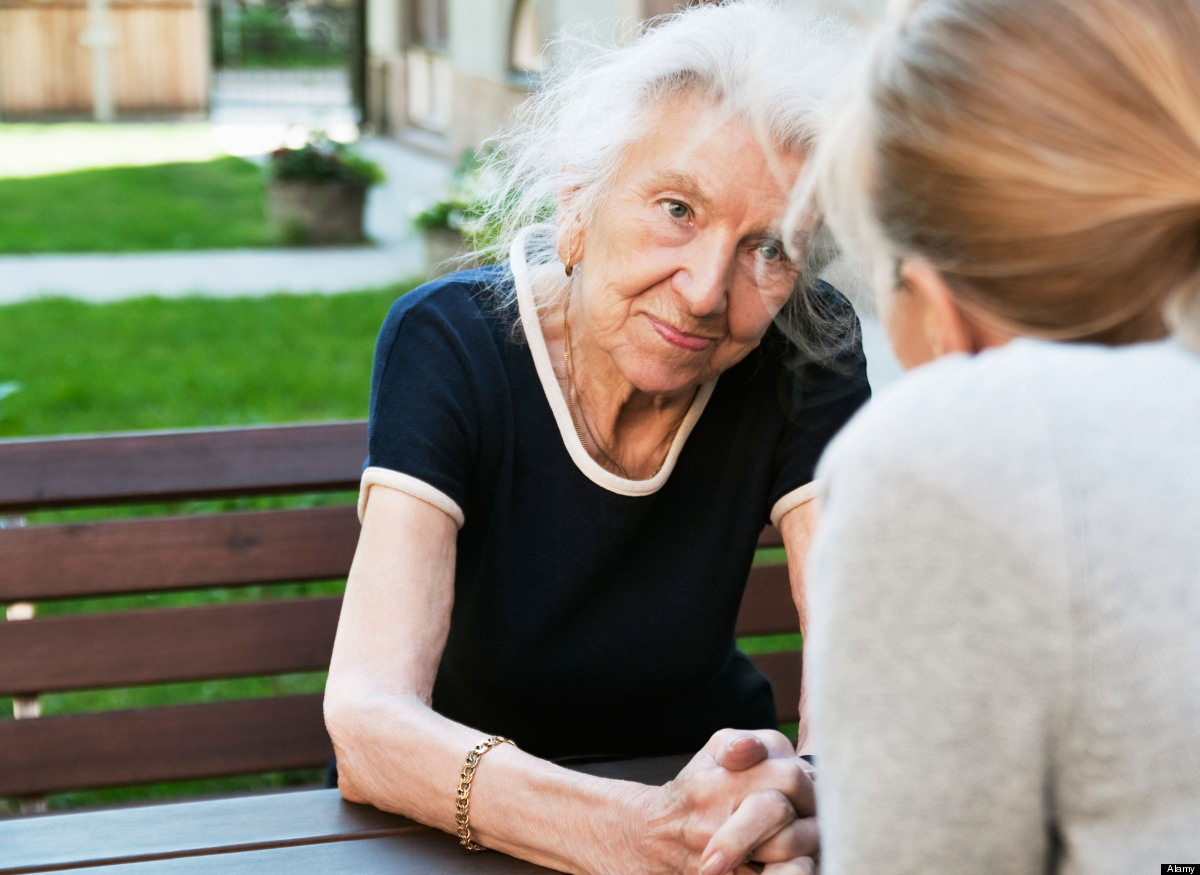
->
xmin=769 ymin=283 xmax=871 ymax=525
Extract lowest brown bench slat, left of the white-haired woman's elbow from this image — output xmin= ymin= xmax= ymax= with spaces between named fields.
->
xmin=0 ymin=693 xmax=334 ymax=797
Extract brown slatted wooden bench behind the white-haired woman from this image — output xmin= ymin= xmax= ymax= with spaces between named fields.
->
xmin=0 ymin=421 xmax=800 ymax=799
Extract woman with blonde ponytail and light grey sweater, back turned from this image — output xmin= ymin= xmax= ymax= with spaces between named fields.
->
xmin=808 ymin=0 xmax=1200 ymax=875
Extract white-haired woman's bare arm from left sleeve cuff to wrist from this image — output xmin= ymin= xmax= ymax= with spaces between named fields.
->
xmin=325 ymin=487 xmax=667 ymax=873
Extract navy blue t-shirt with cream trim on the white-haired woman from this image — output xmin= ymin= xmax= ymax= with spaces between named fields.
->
xmin=365 ymin=261 xmax=870 ymax=759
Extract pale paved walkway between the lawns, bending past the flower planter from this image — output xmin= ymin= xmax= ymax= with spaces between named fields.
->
xmin=0 ymin=139 xmax=450 ymax=304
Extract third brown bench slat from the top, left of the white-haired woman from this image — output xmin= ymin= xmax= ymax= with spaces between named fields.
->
xmin=0 ymin=597 xmax=342 ymax=696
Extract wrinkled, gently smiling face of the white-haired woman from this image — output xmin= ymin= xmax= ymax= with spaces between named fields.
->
xmin=571 ymin=95 xmax=802 ymax=395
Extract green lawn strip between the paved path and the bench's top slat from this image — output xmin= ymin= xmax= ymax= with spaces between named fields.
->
xmin=0 ymin=286 xmax=409 ymax=437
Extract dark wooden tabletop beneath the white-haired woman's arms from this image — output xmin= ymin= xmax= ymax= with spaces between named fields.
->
xmin=0 ymin=756 xmax=688 ymax=875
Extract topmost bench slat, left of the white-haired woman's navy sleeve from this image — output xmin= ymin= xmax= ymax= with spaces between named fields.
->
xmin=0 ymin=421 xmax=367 ymax=514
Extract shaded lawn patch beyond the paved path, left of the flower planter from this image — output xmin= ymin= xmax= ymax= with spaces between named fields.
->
xmin=0 ymin=156 xmax=277 ymax=254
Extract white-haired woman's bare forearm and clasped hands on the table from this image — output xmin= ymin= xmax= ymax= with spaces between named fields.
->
xmin=326 ymin=689 xmax=816 ymax=875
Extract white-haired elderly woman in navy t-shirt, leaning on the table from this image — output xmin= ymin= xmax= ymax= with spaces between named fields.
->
xmin=326 ymin=4 xmax=869 ymax=875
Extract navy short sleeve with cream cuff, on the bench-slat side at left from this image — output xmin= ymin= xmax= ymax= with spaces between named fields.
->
xmin=359 ymin=282 xmax=498 ymax=526
